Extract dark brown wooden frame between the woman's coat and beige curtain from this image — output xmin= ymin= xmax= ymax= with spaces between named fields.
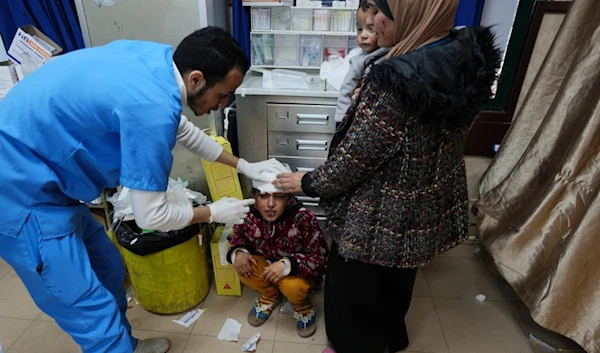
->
xmin=465 ymin=0 xmax=572 ymax=156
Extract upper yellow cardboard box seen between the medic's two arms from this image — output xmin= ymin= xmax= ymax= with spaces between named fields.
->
xmin=202 ymin=136 xmax=244 ymax=202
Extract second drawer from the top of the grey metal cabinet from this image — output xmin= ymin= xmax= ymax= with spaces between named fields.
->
xmin=267 ymin=132 xmax=333 ymax=158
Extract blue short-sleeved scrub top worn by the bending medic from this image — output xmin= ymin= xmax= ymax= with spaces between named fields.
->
xmin=0 ymin=40 xmax=182 ymax=236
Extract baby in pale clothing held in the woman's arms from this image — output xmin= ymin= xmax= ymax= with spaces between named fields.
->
xmin=334 ymin=0 xmax=389 ymax=122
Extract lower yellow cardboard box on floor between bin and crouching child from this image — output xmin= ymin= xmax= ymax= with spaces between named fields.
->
xmin=210 ymin=226 xmax=242 ymax=297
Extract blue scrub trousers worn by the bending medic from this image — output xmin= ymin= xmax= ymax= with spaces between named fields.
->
xmin=0 ymin=210 xmax=137 ymax=353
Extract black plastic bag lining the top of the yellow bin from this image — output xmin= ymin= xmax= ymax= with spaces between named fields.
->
xmin=115 ymin=221 xmax=200 ymax=256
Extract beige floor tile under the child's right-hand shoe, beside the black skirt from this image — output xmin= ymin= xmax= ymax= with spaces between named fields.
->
xmin=275 ymin=290 xmax=328 ymax=345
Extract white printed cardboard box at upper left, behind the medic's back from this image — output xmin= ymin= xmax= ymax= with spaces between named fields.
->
xmin=8 ymin=25 xmax=62 ymax=80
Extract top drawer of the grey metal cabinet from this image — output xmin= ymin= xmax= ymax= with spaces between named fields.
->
xmin=267 ymin=104 xmax=335 ymax=134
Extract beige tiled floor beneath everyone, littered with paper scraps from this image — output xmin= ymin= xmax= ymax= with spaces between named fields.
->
xmin=0 ymin=245 xmax=584 ymax=353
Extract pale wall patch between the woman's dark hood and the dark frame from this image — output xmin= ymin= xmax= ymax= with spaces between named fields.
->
xmin=481 ymin=0 xmax=519 ymax=59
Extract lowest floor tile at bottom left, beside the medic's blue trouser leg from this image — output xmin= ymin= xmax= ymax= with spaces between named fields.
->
xmin=7 ymin=321 xmax=81 ymax=353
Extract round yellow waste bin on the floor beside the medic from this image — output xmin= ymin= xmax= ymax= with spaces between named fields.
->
xmin=122 ymin=228 xmax=210 ymax=315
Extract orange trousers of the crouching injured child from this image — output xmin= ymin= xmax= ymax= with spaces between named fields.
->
xmin=240 ymin=255 xmax=314 ymax=307
